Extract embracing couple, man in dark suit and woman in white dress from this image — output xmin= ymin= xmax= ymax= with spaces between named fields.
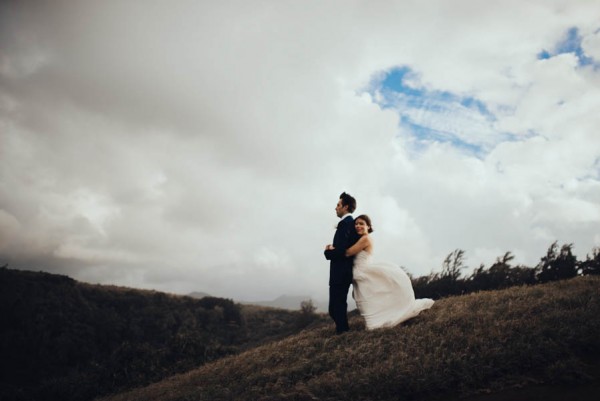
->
xmin=325 ymin=192 xmax=433 ymax=334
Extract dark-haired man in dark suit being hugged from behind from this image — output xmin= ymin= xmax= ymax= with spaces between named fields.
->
xmin=325 ymin=192 xmax=358 ymax=334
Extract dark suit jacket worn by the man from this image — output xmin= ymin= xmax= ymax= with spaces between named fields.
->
xmin=325 ymin=216 xmax=358 ymax=286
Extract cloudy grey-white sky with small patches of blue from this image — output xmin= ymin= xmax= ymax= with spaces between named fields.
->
xmin=0 ymin=0 xmax=600 ymax=301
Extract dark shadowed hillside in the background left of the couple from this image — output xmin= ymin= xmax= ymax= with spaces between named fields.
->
xmin=0 ymin=268 xmax=325 ymax=401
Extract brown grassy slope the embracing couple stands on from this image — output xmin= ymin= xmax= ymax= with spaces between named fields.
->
xmin=99 ymin=277 xmax=600 ymax=401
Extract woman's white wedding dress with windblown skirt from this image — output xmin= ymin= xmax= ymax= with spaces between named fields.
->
xmin=352 ymin=251 xmax=434 ymax=330
